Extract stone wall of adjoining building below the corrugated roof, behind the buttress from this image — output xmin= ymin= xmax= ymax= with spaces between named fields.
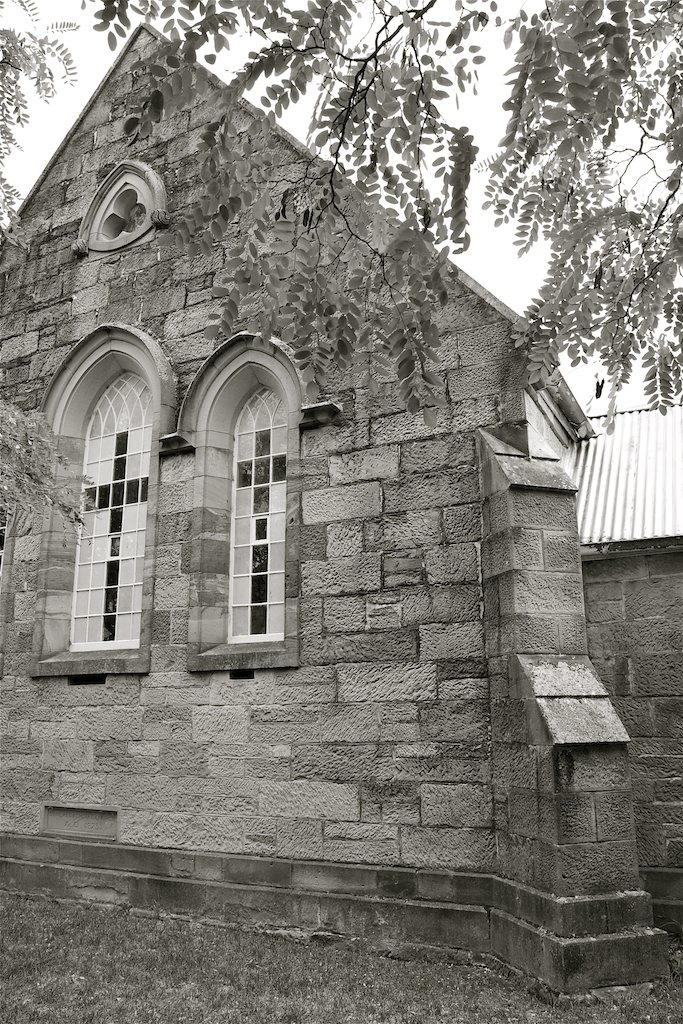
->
xmin=584 ymin=551 xmax=683 ymax=921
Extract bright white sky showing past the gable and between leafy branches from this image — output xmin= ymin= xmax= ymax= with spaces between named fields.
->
xmin=3 ymin=0 xmax=646 ymax=416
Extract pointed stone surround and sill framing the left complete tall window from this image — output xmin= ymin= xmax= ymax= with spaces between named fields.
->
xmin=32 ymin=325 xmax=175 ymax=676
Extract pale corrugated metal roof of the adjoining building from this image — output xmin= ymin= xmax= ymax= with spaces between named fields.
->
xmin=562 ymin=406 xmax=683 ymax=544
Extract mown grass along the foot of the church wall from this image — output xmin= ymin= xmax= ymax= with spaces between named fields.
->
xmin=0 ymin=894 xmax=683 ymax=1024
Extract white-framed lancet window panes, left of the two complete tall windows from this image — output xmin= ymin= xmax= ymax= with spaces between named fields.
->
xmin=71 ymin=373 xmax=152 ymax=650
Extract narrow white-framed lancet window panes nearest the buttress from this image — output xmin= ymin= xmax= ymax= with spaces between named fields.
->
xmin=229 ymin=388 xmax=287 ymax=643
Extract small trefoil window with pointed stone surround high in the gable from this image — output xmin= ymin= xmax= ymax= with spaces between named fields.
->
xmin=76 ymin=160 xmax=168 ymax=255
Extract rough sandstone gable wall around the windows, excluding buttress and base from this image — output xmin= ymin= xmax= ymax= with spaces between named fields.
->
xmin=0 ymin=29 xmax=522 ymax=870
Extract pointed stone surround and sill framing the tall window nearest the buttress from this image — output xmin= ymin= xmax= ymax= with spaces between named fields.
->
xmin=178 ymin=335 xmax=302 ymax=671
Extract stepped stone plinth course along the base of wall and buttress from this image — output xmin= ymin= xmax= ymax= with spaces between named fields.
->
xmin=0 ymin=836 xmax=668 ymax=992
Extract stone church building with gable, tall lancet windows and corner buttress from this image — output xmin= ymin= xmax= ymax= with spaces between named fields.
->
xmin=0 ymin=30 xmax=683 ymax=991
